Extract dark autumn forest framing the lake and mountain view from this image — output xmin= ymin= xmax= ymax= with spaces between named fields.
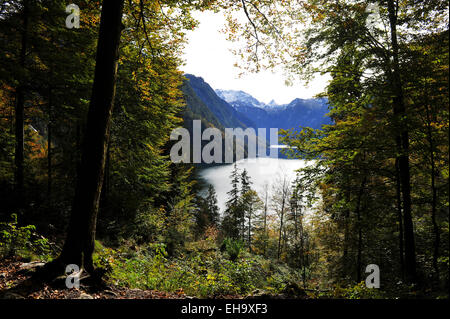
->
xmin=0 ymin=0 xmax=449 ymax=299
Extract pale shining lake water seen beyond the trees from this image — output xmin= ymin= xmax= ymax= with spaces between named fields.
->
xmin=199 ymin=157 xmax=307 ymax=213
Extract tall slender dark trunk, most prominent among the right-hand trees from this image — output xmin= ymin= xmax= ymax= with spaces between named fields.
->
xmin=388 ymin=0 xmax=417 ymax=283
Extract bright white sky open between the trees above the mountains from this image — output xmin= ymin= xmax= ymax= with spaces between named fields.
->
xmin=181 ymin=12 xmax=327 ymax=104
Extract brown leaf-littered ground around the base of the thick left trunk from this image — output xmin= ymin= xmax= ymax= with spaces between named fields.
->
xmin=0 ymin=258 xmax=225 ymax=299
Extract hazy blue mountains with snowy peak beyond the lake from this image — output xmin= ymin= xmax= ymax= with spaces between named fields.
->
xmin=182 ymin=74 xmax=331 ymax=162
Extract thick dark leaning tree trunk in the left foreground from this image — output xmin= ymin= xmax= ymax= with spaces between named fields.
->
xmin=59 ymin=0 xmax=124 ymax=272
